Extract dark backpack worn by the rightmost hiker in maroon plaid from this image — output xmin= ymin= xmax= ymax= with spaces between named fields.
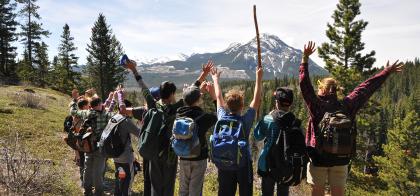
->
xmin=315 ymin=103 xmax=357 ymax=158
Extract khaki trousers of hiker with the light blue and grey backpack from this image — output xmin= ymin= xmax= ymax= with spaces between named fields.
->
xmin=179 ymin=159 xmax=207 ymax=196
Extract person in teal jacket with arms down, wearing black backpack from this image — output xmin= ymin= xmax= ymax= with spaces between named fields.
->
xmin=254 ymin=87 xmax=300 ymax=196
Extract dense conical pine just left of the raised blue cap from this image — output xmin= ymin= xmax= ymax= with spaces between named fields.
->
xmin=85 ymin=14 xmax=125 ymax=98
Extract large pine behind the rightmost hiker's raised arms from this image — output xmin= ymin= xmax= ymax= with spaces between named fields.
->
xmin=318 ymin=0 xmax=375 ymax=91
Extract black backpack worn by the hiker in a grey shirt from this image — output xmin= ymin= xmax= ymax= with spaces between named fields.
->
xmin=98 ymin=114 xmax=129 ymax=158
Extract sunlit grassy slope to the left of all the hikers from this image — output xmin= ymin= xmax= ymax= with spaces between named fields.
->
xmin=0 ymin=86 xmax=82 ymax=195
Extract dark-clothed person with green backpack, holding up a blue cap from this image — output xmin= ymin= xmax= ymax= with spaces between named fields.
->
xmin=125 ymin=57 xmax=213 ymax=196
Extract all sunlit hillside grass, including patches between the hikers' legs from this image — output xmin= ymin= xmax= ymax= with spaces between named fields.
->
xmin=0 ymin=86 xmax=314 ymax=195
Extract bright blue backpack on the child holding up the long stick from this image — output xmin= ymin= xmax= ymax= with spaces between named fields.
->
xmin=210 ymin=116 xmax=248 ymax=170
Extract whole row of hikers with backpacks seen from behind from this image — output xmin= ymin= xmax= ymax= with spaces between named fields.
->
xmin=66 ymin=42 xmax=402 ymax=196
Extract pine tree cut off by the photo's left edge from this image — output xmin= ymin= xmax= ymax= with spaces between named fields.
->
xmin=0 ymin=0 xmax=18 ymax=82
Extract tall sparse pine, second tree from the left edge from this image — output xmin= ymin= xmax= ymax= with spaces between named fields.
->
xmin=16 ymin=0 xmax=50 ymax=71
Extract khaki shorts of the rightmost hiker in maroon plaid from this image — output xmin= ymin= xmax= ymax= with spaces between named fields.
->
xmin=307 ymin=162 xmax=348 ymax=187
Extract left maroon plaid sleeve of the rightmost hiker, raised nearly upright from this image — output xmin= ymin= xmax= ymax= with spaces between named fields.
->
xmin=299 ymin=63 xmax=320 ymax=116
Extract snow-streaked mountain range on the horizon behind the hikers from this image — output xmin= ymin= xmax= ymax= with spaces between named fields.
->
xmin=124 ymin=34 xmax=327 ymax=85
